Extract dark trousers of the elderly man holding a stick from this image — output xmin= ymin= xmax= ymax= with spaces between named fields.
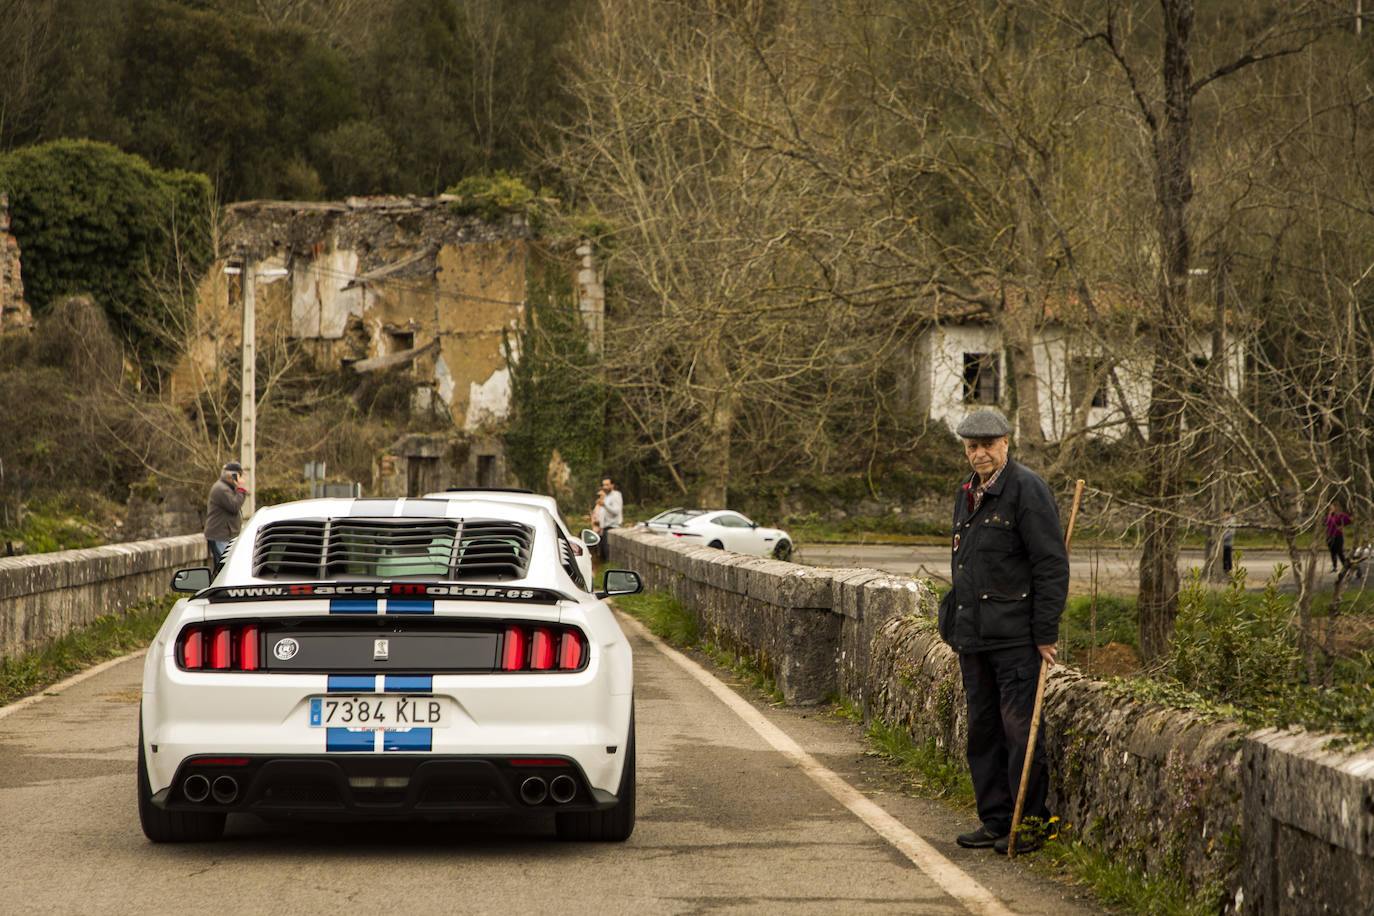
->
xmin=959 ymin=645 xmax=1050 ymax=834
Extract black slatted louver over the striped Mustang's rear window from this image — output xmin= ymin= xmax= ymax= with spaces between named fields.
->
xmin=253 ymin=518 xmax=534 ymax=581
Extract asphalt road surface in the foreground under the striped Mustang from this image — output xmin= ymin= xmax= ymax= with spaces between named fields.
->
xmin=0 ymin=612 xmax=1102 ymax=916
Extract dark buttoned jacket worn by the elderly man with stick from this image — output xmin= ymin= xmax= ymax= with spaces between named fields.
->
xmin=940 ymin=457 xmax=1069 ymax=652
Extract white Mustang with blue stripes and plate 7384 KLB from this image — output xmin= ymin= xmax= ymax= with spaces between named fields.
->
xmin=137 ymin=493 xmax=640 ymax=842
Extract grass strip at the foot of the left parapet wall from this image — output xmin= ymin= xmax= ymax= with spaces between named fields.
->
xmin=0 ymin=595 xmax=179 ymax=706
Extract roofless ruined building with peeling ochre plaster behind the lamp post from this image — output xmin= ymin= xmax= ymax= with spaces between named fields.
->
xmin=172 ymin=198 xmax=605 ymax=496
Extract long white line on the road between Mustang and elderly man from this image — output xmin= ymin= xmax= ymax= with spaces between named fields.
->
xmin=620 ymin=614 xmax=1011 ymax=916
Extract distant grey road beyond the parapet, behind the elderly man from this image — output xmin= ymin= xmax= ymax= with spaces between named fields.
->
xmin=793 ymin=544 xmax=1334 ymax=595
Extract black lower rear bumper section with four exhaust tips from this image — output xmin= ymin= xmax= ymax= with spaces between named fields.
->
xmin=153 ymin=754 xmax=617 ymax=820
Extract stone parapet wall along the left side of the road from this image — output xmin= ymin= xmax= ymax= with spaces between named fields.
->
xmin=0 ymin=534 xmax=206 ymax=658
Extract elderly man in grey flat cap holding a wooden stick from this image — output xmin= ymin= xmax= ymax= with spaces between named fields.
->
xmin=940 ymin=408 xmax=1069 ymax=853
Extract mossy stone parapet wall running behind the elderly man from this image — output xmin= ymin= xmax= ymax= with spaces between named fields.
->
xmin=609 ymin=529 xmax=1374 ymax=913
